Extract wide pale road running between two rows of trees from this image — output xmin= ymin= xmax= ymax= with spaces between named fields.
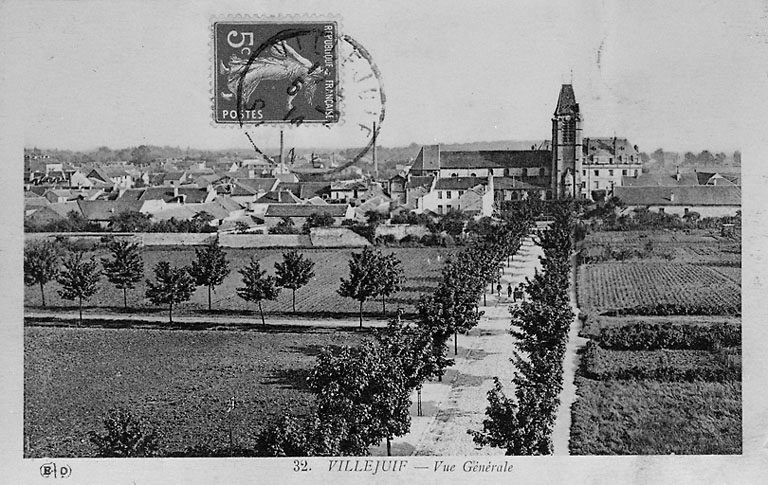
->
xmin=371 ymin=238 xmax=543 ymax=456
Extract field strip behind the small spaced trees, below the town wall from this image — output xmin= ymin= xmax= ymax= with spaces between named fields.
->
xmin=24 ymin=248 xmax=451 ymax=318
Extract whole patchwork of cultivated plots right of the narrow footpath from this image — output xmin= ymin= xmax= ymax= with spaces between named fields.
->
xmin=570 ymin=227 xmax=742 ymax=455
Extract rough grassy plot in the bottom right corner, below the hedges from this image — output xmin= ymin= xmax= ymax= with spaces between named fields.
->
xmin=570 ymin=378 xmax=742 ymax=455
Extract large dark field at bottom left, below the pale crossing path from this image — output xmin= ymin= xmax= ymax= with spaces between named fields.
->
xmin=24 ymin=327 xmax=364 ymax=457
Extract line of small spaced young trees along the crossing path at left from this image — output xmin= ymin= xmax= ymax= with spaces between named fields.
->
xmin=24 ymin=235 xmax=404 ymax=327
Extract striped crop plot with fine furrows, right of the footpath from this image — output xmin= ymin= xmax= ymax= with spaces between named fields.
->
xmin=578 ymin=262 xmax=741 ymax=313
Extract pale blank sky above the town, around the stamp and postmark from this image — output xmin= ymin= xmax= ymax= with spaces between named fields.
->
xmin=0 ymin=0 xmax=767 ymax=152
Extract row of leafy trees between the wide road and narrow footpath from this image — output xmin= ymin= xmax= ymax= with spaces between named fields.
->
xmin=470 ymin=203 xmax=575 ymax=455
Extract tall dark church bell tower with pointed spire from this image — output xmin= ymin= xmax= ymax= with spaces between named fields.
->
xmin=552 ymin=84 xmax=589 ymax=199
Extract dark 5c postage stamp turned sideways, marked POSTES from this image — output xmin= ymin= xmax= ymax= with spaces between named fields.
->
xmin=213 ymin=20 xmax=339 ymax=125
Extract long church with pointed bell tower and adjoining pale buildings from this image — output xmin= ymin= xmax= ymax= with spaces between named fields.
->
xmin=403 ymin=84 xmax=642 ymax=215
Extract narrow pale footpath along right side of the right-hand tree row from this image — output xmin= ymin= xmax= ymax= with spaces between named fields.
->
xmin=552 ymin=258 xmax=587 ymax=455
